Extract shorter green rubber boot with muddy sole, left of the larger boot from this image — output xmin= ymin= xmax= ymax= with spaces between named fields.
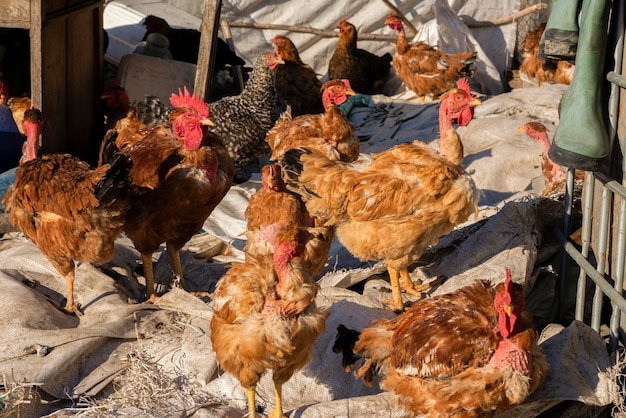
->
xmin=538 ymin=0 xmax=580 ymax=61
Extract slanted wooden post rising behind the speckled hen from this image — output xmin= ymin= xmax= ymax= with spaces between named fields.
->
xmin=194 ymin=0 xmax=222 ymax=102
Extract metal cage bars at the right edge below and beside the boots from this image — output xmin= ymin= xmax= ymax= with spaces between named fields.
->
xmin=557 ymin=0 xmax=626 ymax=353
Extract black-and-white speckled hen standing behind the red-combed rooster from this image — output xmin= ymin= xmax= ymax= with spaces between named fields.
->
xmin=211 ymin=52 xmax=284 ymax=168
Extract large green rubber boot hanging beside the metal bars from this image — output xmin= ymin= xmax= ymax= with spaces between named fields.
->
xmin=548 ymin=0 xmax=610 ymax=171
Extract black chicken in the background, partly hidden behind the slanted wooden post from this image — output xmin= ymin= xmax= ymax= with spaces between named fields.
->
xmin=143 ymin=15 xmax=245 ymax=73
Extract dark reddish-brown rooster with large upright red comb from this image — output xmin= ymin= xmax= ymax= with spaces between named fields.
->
xmin=101 ymin=88 xmax=235 ymax=302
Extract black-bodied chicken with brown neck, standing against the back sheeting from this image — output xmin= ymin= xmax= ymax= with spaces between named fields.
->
xmin=328 ymin=19 xmax=392 ymax=94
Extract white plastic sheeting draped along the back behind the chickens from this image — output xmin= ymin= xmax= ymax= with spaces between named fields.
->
xmin=104 ymin=0 xmax=536 ymax=95
